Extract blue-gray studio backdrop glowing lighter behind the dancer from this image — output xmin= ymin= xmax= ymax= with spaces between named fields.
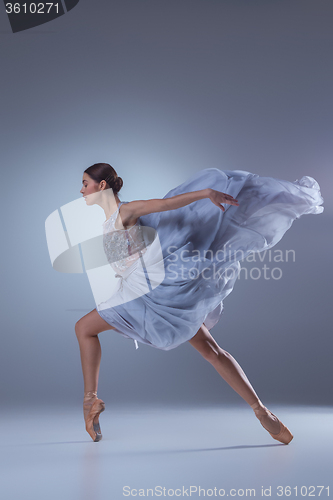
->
xmin=0 ymin=0 xmax=333 ymax=407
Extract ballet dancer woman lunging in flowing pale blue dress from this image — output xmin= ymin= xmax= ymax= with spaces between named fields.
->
xmin=75 ymin=163 xmax=323 ymax=444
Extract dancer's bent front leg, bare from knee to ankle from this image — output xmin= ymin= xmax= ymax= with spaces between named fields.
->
xmin=75 ymin=309 xmax=114 ymax=393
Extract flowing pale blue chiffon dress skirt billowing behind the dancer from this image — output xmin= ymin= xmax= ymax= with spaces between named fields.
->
xmin=97 ymin=168 xmax=324 ymax=350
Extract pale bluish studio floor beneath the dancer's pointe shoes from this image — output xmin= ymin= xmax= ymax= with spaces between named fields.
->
xmin=0 ymin=405 xmax=333 ymax=500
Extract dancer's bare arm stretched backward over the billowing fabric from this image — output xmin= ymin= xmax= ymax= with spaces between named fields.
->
xmin=120 ymin=188 xmax=238 ymax=226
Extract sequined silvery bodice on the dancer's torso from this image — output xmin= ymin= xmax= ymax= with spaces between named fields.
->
xmin=103 ymin=202 xmax=146 ymax=274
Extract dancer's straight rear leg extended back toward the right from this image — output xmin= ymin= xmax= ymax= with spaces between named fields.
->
xmin=189 ymin=324 xmax=280 ymax=434
